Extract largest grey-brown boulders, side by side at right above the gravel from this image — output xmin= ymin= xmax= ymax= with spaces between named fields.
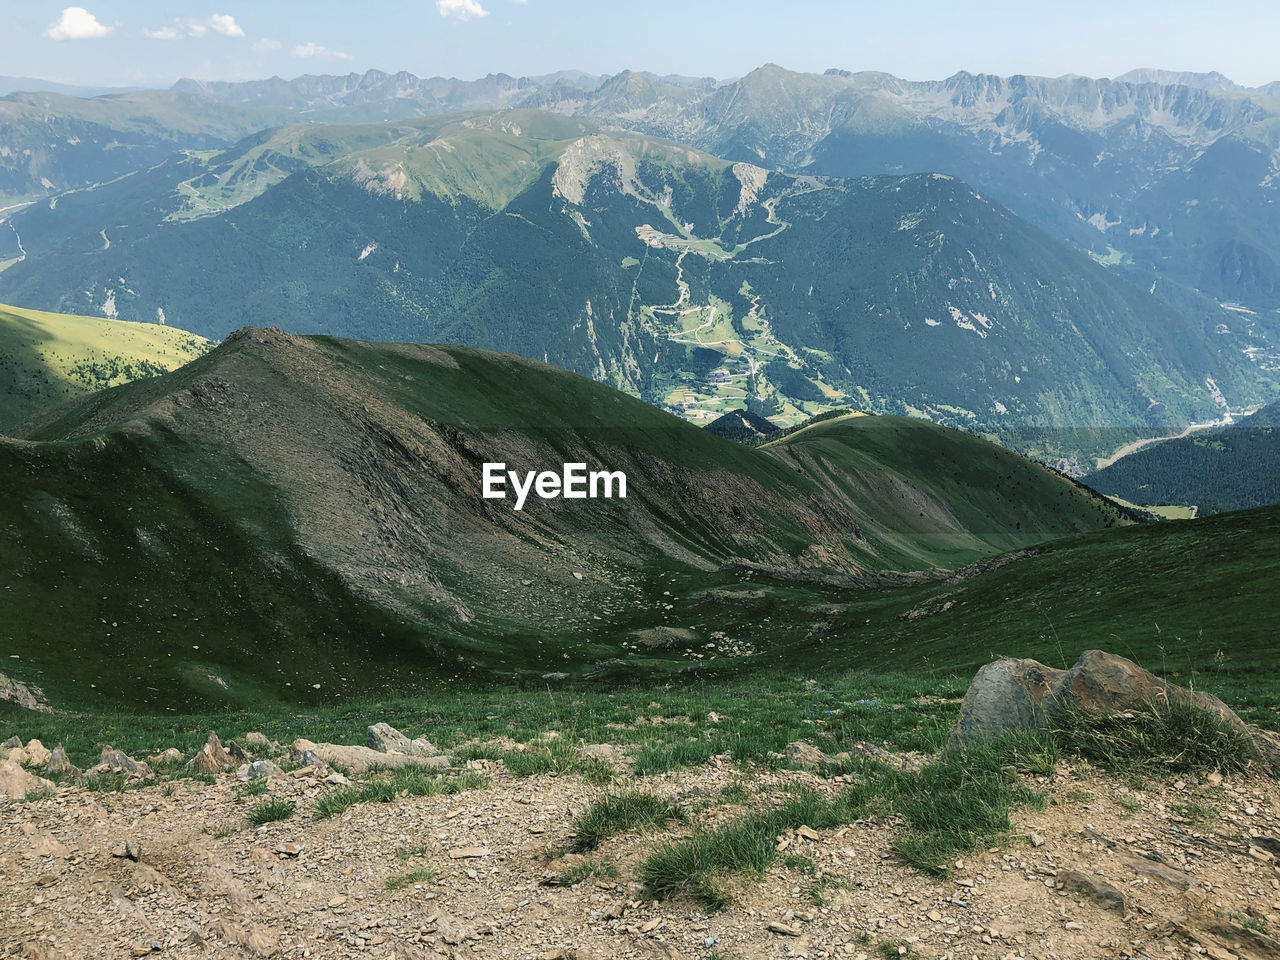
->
xmin=947 ymin=650 xmax=1280 ymax=765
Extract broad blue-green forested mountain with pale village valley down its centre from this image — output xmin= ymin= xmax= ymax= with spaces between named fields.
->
xmin=0 ymin=111 xmax=1277 ymax=456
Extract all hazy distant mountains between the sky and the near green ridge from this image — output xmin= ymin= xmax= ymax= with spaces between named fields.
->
xmin=0 ymin=65 xmax=1280 ymax=460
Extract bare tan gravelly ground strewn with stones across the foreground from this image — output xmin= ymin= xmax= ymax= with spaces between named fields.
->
xmin=0 ymin=737 xmax=1280 ymax=960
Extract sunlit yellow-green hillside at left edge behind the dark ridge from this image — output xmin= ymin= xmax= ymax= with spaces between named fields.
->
xmin=0 ymin=303 xmax=212 ymax=433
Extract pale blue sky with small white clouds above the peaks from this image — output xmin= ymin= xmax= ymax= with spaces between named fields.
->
xmin=0 ymin=0 xmax=1280 ymax=86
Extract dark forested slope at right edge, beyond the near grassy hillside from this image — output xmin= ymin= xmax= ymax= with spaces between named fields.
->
xmin=1088 ymin=403 xmax=1280 ymax=515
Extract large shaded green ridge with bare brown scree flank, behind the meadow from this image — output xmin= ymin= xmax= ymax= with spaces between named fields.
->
xmin=0 ymin=330 xmax=1116 ymax=709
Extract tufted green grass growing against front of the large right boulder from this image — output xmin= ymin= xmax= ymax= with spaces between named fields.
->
xmin=1051 ymin=703 xmax=1258 ymax=776
